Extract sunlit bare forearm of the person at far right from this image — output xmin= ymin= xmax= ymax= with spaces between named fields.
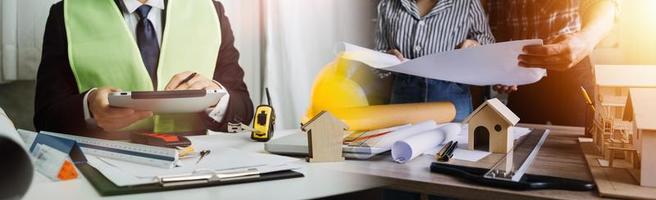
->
xmin=580 ymin=1 xmax=616 ymax=48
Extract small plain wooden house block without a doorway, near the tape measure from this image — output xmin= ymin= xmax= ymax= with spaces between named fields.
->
xmin=301 ymin=111 xmax=348 ymax=162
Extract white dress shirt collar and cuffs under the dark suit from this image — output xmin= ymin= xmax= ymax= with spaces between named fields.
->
xmin=83 ymin=0 xmax=230 ymax=126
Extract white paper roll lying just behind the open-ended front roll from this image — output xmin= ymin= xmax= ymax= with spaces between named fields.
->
xmin=374 ymin=120 xmax=437 ymax=149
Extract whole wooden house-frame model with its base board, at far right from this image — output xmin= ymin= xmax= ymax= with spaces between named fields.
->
xmin=579 ymin=65 xmax=656 ymax=199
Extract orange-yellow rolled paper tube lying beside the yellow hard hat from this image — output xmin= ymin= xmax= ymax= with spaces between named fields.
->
xmin=329 ymin=102 xmax=456 ymax=131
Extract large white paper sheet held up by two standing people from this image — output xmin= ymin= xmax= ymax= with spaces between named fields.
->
xmin=343 ymin=39 xmax=547 ymax=86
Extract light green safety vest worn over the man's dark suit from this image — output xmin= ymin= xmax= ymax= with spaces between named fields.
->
xmin=64 ymin=0 xmax=221 ymax=133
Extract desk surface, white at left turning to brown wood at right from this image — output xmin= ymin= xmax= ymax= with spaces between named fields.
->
xmin=25 ymin=125 xmax=598 ymax=200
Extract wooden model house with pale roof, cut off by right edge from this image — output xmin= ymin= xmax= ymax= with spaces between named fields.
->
xmin=624 ymin=88 xmax=656 ymax=187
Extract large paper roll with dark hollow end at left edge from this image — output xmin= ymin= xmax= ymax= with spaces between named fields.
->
xmin=0 ymin=108 xmax=34 ymax=199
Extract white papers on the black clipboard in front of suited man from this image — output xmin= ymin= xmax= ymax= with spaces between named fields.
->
xmin=87 ymin=145 xmax=300 ymax=187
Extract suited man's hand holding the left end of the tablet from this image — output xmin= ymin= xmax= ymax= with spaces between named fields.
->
xmin=87 ymin=87 xmax=153 ymax=132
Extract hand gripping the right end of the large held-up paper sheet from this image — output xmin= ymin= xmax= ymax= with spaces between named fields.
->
xmin=518 ymin=33 xmax=594 ymax=71
